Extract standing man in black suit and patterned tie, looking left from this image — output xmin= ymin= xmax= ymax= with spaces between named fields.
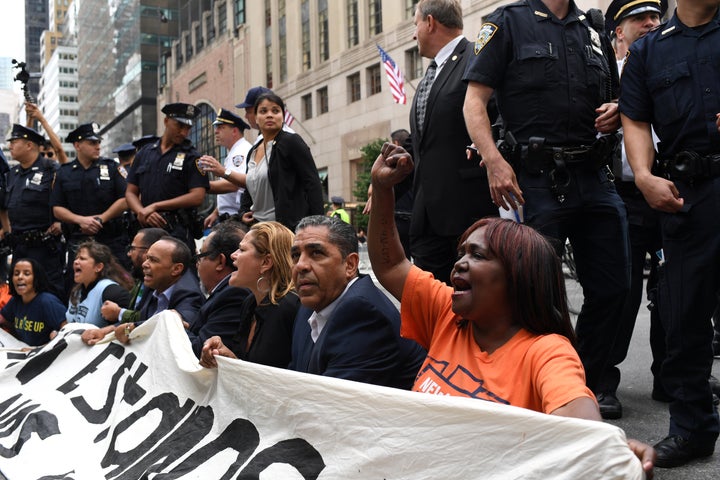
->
xmin=410 ymin=0 xmax=498 ymax=283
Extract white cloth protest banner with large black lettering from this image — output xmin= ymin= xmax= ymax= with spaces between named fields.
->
xmin=0 ymin=312 xmax=644 ymax=480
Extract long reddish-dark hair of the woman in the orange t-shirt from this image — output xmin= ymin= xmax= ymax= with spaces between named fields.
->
xmin=458 ymin=218 xmax=575 ymax=343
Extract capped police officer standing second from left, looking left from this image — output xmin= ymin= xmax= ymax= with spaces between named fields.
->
xmin=50 ymin=123 xmax=129 ymax=288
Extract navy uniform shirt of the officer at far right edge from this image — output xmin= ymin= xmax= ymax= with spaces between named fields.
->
xmin=620 ymin=10 xmax=720 ymax=157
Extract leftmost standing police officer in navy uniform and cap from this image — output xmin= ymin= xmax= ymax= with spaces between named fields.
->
xmin=3 ymin=124 xmax=66 ymax=300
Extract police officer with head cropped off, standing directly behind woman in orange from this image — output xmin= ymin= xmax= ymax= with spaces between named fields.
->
xmin=463 ymin=0 xmax=630 ymax=406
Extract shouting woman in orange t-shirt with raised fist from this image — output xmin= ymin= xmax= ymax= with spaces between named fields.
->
xmin=368 ymin=143 xmax=655 ymax=471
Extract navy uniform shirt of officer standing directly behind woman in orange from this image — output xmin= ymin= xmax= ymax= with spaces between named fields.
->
xmin=464 ymin=0 xmax=618 ymax=146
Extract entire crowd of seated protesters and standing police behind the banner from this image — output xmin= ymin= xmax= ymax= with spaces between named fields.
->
xmin=0 ymin=0 xmax=720 ymax=472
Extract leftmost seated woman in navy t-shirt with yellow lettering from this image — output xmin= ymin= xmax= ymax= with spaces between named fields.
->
xmin=0 ymin=258 xmax=67 ymax=347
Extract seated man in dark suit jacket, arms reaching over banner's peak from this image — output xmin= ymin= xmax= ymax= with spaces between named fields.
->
xmin=82 ymin=235 xmax=205 ymax=345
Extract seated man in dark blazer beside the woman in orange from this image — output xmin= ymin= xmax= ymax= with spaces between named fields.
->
xmin=290 ymin=215 xmax=426 ymax=389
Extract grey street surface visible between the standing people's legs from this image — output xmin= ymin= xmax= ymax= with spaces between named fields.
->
xmin=360 ymin=248 xmax=720 ymax=480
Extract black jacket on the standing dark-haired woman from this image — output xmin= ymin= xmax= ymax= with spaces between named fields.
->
xmin=240 ymin=130 xmax=325 ymax=231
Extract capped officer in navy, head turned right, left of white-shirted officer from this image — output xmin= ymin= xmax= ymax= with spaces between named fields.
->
xmin=125 ymin=103 xmax=209 ymax=252
